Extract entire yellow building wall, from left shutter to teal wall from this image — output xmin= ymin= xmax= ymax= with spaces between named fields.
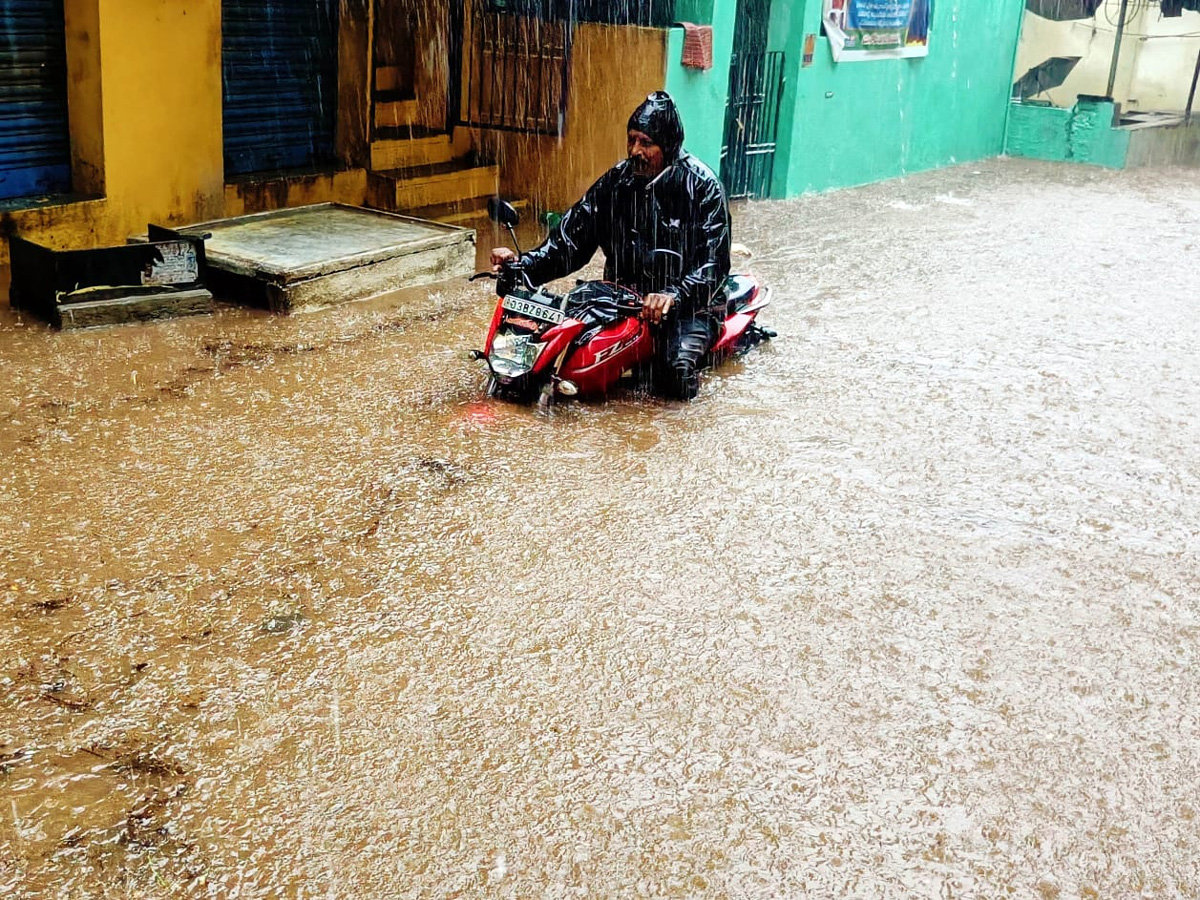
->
xmin=0 ymin=0 xmax=666 ymax=278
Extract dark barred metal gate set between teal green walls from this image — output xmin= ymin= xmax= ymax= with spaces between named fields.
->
xmin=721 ymin=52 xmax=784 ymax=199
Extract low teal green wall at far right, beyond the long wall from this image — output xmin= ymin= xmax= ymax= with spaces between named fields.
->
xmin=1004 ymin=100 xmax=1129 ymax=169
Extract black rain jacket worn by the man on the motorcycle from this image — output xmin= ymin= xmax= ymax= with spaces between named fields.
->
xmin=521 ymin=154 xmax=730 ymax=318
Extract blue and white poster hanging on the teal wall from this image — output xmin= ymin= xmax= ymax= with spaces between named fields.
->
xmin=824 ymin=0 xmax=934 ymax=62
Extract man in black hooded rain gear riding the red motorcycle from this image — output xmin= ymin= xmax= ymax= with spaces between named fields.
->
xmin=492 ymin=91 xmax=730 ymax=400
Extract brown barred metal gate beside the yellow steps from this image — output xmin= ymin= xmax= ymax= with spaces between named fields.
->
xmin=458 ymin=0 xmax=572 ymax=136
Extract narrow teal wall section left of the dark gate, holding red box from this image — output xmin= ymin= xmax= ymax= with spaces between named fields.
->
xmin=666 ymin=0 xmax=734 ymax=173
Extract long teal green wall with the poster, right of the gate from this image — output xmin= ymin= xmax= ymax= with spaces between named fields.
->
xmin=770 ymin=0 xmax=1025 ymax=197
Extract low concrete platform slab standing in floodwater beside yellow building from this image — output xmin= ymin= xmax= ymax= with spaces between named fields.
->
xmin=176 ymin=203 xmax=475 ymax=312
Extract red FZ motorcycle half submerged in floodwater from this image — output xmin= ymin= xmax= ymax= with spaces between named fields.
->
xmin=470 ymin=198 xmax=775 ymax=406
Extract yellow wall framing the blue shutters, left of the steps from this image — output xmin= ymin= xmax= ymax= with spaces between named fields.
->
xmin=0 ymin=0 xmax=370 ymax=274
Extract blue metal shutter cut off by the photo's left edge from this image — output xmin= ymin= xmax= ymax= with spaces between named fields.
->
xmin=0 ymin=0 xmax=71 ymax=199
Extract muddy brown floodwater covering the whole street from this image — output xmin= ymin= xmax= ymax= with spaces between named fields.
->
xmin=0 ymin=160 xmax=1200 ymax=900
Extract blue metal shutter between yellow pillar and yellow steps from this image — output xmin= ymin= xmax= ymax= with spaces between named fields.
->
xmin=221 ymin=0 xmax=337 ymax=178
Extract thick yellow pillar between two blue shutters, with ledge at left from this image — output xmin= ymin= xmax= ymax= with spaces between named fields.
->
xmin=0 ymin=0 xmax=224 ymax=271
